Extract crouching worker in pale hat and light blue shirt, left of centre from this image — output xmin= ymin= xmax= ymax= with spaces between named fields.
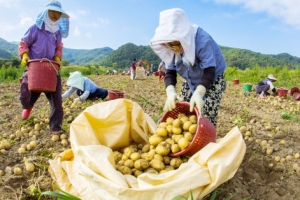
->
xmin=62 ymin=71 xmax=108 ymax=101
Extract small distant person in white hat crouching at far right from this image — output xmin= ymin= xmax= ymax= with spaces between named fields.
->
xmin=256 ymin=74 xmax=277 ymax=99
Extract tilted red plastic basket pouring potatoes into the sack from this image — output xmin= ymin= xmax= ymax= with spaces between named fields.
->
xmin=159 ymin=102 xmax=217 ymax=157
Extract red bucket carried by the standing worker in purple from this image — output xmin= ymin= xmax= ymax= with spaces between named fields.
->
xmin=28 ymin=59 xmax=60 ymax=92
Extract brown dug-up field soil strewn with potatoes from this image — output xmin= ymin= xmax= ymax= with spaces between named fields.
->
xmin=0 ymin=72 xmax=300 ymax=200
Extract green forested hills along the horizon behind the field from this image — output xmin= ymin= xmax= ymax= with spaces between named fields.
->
xmin=0 ymin=38 xmax=300 ymax=69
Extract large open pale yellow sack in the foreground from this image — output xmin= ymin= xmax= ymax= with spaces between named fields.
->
xmin=49 ymin=99 xmax=246 ymax=200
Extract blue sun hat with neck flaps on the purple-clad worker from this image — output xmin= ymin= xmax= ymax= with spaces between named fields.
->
xmin=36 ymin=0 xmax=70 ymax=38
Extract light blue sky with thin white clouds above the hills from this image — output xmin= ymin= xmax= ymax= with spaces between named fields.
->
xmin=0 ymin=0 xmax=300 ymax=57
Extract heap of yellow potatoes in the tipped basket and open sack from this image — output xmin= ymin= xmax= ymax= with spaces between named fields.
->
xmin=113 ymin=113 xmax=197 ymax=177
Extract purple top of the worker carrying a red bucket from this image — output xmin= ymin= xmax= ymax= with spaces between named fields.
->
xmin=21 ymin=24 xmax=62 ymax=60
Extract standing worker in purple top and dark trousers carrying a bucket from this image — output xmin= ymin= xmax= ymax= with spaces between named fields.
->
xmin=19 ymin=1 xmax=69 ymax=134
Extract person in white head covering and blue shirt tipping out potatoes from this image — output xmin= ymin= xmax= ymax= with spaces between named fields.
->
xmin=150 ymin=8 xmax=226 ymax=127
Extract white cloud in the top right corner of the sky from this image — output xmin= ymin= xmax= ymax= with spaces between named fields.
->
xmin=214 ymin=0 xmax=300 ymax=29
